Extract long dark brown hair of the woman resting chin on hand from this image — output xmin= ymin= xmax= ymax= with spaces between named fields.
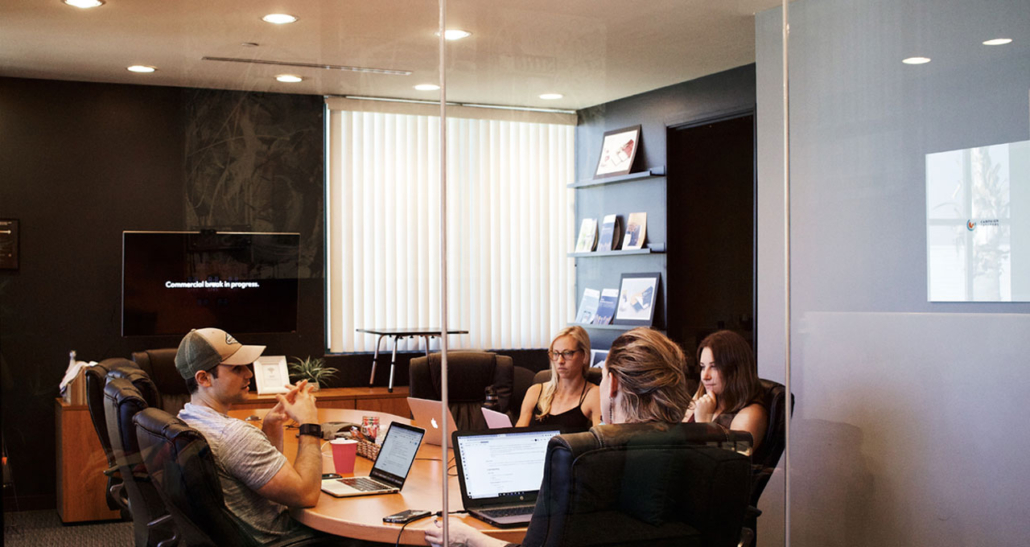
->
xmin=691 ymin=331 xmax=761 ymax=414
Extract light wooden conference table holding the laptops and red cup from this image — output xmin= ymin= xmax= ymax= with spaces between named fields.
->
xmin=229 ymin=409 xmax=525 ymax=545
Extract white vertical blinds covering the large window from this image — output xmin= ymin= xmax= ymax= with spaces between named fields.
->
xmin=325 ymin=108 xmax=575 ymax=352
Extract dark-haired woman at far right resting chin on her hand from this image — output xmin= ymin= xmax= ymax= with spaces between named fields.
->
xmin=684 ymin=331 xmax=768 ymax=450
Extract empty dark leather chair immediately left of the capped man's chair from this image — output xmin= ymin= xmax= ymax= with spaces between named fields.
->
xmin=104 ymin=377 xmax=178 ymax=547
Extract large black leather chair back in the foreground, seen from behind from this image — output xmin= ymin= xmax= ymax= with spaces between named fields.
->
xmin=522 ymin=423 xmax=751 ymax=547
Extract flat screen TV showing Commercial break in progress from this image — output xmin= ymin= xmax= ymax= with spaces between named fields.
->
xmin=122 ymin=232 xmax=301 ymax=336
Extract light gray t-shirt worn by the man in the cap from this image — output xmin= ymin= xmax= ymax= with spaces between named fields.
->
xmin=179 ymin=403 xmax=310 ymax=543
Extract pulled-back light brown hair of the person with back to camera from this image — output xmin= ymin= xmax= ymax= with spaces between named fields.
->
xmin=606 ymin=328 xmax=690 ymax=423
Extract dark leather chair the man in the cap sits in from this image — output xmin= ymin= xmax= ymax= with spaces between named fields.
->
xmin=133 ymin=408 xmax=323 ymax=547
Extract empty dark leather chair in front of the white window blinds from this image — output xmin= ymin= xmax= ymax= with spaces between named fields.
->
xmin=408 ymin=351 xmax=514 ymax=431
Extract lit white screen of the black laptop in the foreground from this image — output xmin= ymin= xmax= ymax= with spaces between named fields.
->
xmin=457 ymin=431 xmax=561 ymax=500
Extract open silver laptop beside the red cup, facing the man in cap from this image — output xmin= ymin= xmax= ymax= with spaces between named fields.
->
xmin=321 ymin=421 xmax=425 ymax=498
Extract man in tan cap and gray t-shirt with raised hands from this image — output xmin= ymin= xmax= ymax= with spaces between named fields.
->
xmin=175 ymin=329 xmax=321 ymax=543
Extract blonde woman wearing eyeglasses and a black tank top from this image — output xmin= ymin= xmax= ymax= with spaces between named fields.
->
xmin=516 ymin=327 xmax=600 ymax=428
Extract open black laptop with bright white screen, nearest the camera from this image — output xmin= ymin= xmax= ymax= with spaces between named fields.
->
xmin=453 ymin=428 xmax=568 ymax=527
